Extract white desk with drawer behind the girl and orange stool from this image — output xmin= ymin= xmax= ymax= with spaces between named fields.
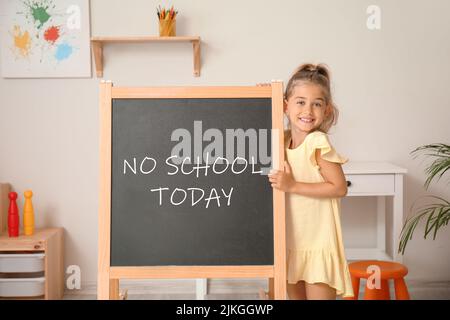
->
xmin=342 ymin=161 xmax=407 ymax=262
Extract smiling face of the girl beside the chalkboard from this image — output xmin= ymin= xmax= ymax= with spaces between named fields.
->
xmin=284 ymin=82 xmax=330 ymax=133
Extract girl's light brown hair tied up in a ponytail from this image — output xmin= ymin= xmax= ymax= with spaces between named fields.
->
xmin=284 ymin=63 xmax=339 ymax=133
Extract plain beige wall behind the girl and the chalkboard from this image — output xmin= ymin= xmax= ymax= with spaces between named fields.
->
xmin=0 ymin=0 xmax=450 ymax=282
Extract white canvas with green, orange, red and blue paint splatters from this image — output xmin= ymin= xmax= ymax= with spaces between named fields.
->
xmin=0 ymin=0 xmax=91 ymax=78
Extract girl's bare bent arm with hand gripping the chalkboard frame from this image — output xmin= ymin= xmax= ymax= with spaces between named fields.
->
xmin=269 ymin=150 xmax=347 ymax=198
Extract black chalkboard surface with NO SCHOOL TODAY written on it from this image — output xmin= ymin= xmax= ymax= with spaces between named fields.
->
xmin=110 ymin=98 xmax=274 ymax=266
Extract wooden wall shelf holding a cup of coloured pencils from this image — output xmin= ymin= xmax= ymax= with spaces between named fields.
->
xmin=91 ymin=36 xmax=200 ymax=77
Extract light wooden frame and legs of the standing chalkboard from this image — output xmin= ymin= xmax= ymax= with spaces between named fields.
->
xmin=97 ymin=81 xmax=286 ymax=300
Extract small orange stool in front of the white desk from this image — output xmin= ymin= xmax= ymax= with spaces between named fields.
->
xmin=348 ymin=260 xmax=409 ymax=300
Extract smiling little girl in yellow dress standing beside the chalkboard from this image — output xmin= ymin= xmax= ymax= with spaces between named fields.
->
xmin=269 ymin=64 xmax=353 ymax=299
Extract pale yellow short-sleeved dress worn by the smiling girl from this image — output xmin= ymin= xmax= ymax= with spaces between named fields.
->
xmin=285 ymin=131 xmax=353 ymax=297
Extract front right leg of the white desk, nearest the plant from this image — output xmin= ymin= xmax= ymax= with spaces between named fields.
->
xmin=392 ymin=174 xmax=403 ymax=263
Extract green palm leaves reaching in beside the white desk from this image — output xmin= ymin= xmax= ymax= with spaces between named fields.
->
xmin=398 ymin=143 xmax=450 ymax=254
